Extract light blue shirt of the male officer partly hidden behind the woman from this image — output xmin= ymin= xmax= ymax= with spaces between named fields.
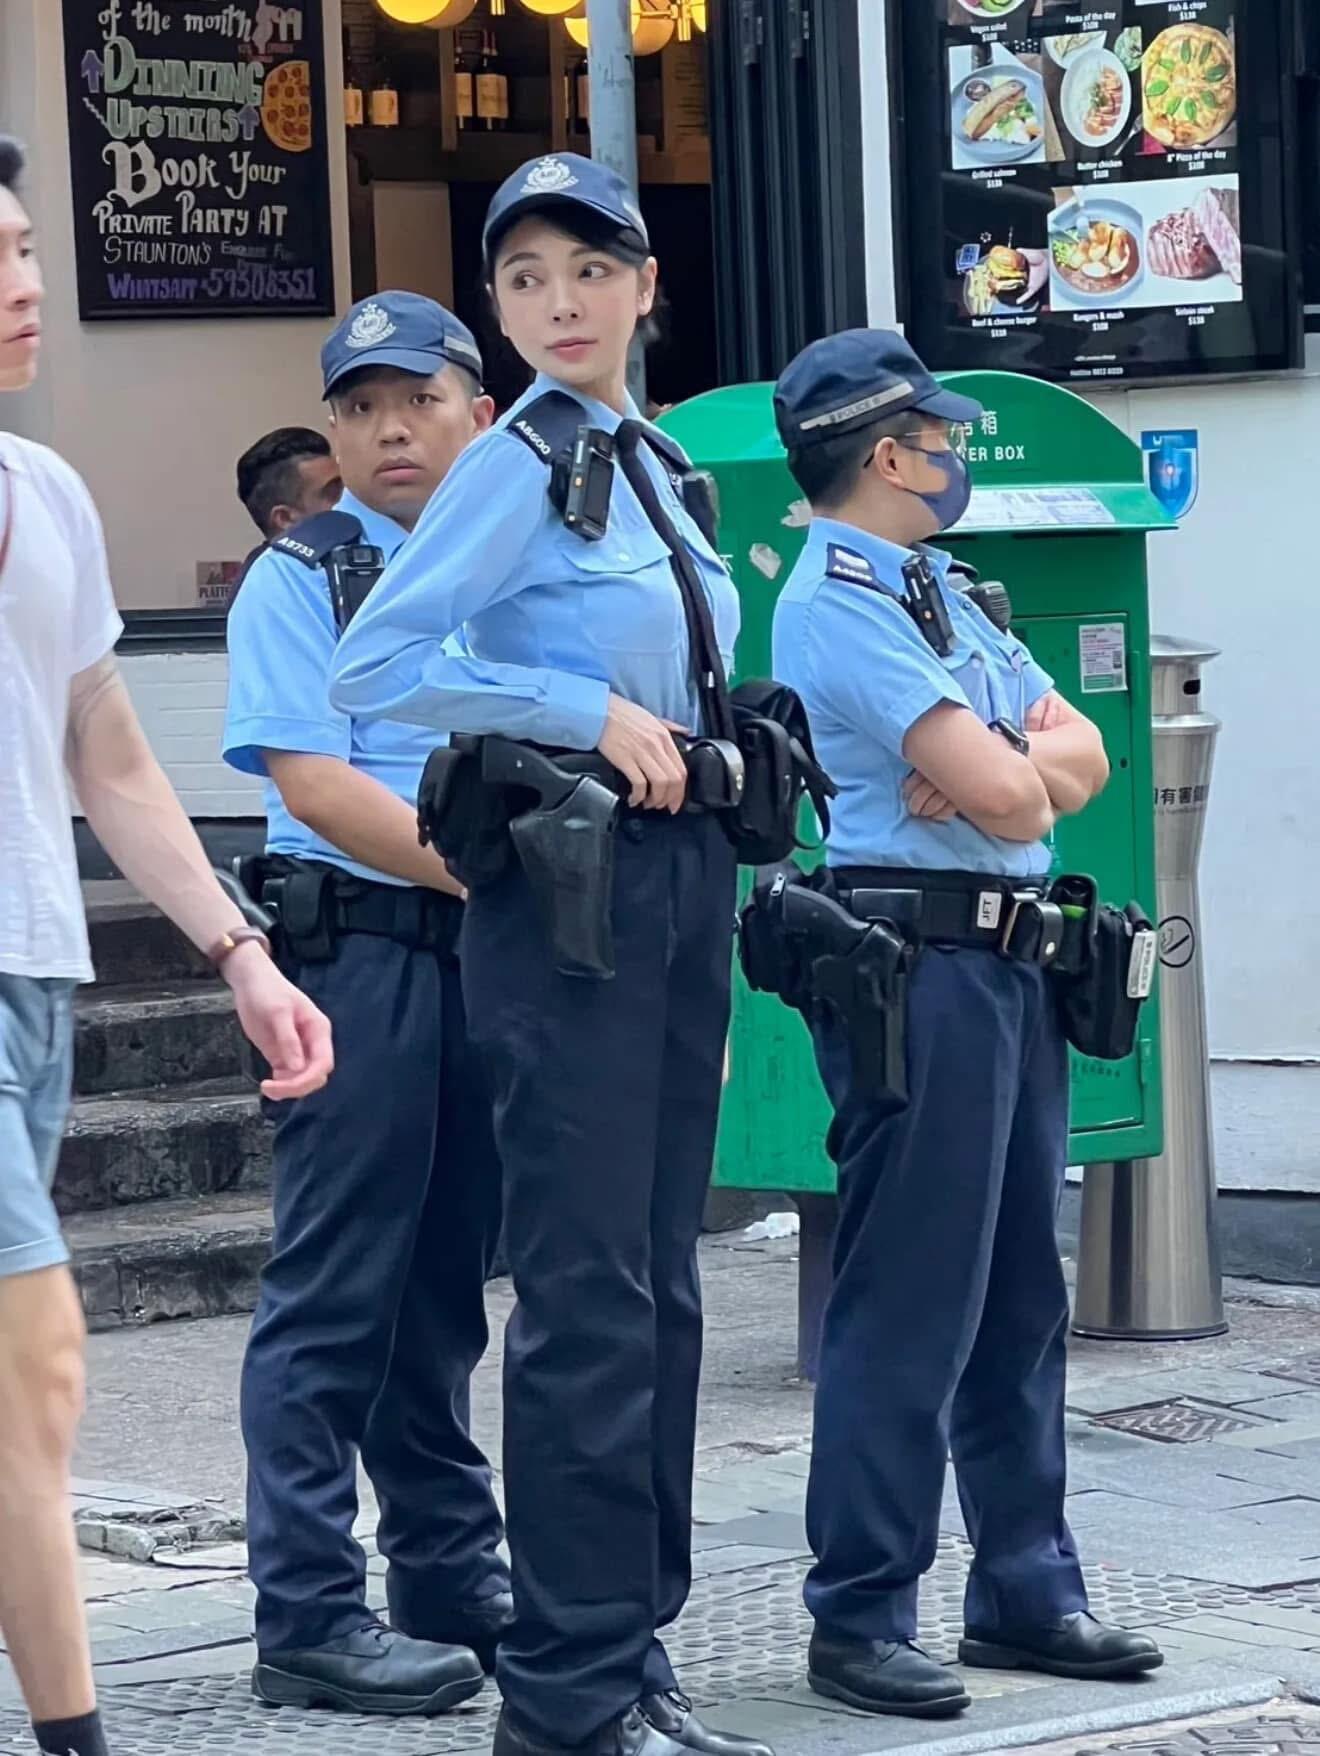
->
xmin=225 ymin=493 xmax=442 ymax=883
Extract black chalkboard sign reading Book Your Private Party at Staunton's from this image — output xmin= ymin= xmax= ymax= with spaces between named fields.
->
xmin=63 ymin=0 xmax=335 ymax=320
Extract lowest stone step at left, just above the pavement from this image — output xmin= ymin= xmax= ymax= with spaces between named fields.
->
xmin=65 ymin=1191 xmax=270 ymax=1329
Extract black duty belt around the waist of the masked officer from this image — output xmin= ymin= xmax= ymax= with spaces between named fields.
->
xmin=830 ymin=866 xmax=1067 ymax=968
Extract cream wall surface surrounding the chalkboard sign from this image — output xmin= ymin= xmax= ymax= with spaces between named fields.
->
xmin=0 ymin=0 xmax=349 ymax=608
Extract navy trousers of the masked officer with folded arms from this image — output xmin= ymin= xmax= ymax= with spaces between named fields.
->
xmin=806 ymin=945 xmax=1087 ymax=1640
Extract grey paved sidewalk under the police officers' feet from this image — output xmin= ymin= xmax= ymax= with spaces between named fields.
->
xmin=0 ymin=1240 xmax=1320 ymax=1756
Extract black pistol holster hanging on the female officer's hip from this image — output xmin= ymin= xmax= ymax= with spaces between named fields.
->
xmin=509 ymin=774 xmax=620 ymax=982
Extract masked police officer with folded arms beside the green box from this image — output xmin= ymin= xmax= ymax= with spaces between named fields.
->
xmin=774 ymin=330 xmax=1160 ymax=1716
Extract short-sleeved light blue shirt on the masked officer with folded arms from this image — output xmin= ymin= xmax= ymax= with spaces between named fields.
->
xmin=774 ymin=518 xmax=1053 ymax=878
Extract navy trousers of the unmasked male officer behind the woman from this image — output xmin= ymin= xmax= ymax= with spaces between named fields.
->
xmin=242 ymin=932 xmax=507 ymax=1652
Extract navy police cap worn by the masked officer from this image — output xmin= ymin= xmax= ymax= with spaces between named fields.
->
xmin=774 ymin=330 xmax=981 ymax=451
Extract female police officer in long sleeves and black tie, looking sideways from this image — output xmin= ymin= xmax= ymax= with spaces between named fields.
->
xmin=332 ymin=155 xmax=772 ymax=1756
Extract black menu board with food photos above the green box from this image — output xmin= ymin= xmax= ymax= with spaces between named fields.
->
xmin=895 ymin=0 xmax=1301 ymax=383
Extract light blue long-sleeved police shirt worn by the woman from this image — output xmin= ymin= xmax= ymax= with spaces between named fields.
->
xmin=330 ymin=378 xmax=739 ymax=750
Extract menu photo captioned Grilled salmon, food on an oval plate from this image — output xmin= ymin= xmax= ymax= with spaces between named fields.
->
xmin=948 ymin=42 xmax=1064 ymax=170
